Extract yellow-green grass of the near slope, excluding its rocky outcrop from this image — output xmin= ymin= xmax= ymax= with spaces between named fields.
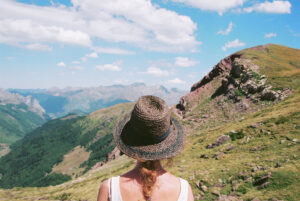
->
xmin=0 ymin=45 xmax=300 ymax=201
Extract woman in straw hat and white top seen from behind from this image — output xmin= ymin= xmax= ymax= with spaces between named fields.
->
xmin=98 ymin=96 xmax=194 ymax=201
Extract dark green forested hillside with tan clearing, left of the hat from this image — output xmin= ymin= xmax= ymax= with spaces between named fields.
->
xmin=0 ymin=103 xmax=132 ymax=188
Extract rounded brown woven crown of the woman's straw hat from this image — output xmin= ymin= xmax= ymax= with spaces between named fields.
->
xmin=130 ymin=96 xmax=171 ymax=141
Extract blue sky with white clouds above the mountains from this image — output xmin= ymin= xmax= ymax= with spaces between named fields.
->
xmin=0 ymin=0 xmax=300 ymax=90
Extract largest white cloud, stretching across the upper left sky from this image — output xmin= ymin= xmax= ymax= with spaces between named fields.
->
xmin=0 ymin=0 xmax=200 ymax=54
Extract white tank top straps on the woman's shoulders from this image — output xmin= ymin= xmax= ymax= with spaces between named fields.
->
xmin=108 ymin=176 xmax=189 ymax=201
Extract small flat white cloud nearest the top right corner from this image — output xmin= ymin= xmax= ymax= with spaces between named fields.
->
xmin=243 ymin=0 xmax=292 ymax=14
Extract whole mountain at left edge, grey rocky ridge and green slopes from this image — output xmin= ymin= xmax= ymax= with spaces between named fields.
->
xmin=0 ymin=89 xmax=47 ymax=144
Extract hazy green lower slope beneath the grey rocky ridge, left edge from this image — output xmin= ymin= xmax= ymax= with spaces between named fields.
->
xmin=0 ymin=104 xmax=46 ymax=144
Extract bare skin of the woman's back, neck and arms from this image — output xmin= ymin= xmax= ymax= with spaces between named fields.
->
xmin=98 ymin=161 xmax=194 ymax=201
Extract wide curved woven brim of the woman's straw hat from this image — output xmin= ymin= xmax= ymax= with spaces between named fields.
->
xmin=114 ymin=113 xmax=185 ymax=160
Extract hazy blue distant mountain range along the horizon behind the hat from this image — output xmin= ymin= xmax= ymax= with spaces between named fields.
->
xmin=9 ymin=83 xmax=186 ymax=118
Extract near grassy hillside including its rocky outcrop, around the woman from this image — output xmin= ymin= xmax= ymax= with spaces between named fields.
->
xmin=0 ymin=44 xmax=300 ymax=201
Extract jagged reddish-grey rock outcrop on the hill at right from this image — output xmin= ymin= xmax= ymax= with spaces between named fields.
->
xmin=176 ymin=53 xmax=291 ymax=114
